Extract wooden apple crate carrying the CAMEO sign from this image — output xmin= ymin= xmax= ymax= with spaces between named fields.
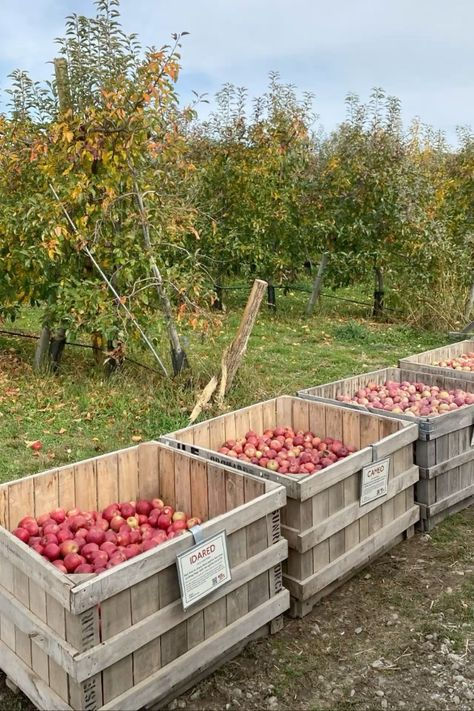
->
xmin=162 ymin=396 xmax=419 ymax=616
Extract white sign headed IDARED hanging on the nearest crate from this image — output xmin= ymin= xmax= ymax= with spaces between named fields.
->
xmin=176 ymin=531 xmax=232 ymax=610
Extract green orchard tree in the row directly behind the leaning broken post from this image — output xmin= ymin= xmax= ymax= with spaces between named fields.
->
xmin=193 ymin=74 xmax=314 ymax=302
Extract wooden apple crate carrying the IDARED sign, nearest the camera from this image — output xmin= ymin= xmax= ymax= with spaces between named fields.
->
xmin=0 ymin=442 xmax=289 ymax=711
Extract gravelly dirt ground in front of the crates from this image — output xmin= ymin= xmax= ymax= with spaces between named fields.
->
xmin=0 ymin=508 xmax=474 ymax=711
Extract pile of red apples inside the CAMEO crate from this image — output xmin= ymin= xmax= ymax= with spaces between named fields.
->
xmin=218 ymin=427 xmax=356 ymax=474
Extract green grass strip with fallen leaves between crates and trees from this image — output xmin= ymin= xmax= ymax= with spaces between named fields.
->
xmin=0 ymin=292 xmax=446 ymax=481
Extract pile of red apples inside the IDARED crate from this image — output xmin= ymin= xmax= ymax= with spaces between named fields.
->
xmin=12 ymin=499 xmax=201 ymax=573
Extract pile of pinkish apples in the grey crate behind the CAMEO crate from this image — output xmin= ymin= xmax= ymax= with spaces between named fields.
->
xmin=337 ymin=380 xmax=474 ymax=417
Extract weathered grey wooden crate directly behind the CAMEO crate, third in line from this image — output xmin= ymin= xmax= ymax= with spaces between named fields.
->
xmin=298 ymin=368 xmax=474 ymax=531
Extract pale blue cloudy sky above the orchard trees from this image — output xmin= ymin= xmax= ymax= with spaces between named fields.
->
xmin=0 ymin=0 xmax=474 ymax=142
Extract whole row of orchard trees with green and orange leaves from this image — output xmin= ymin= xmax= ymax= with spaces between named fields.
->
xmin=0 ymin=0 xmax=474 ymax=373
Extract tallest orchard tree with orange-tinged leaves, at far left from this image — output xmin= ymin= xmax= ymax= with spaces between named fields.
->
xmin=2 ymin=0 xmax=205 ymax=374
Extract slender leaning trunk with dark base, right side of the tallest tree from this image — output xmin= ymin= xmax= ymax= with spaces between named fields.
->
xmin=132 ymin=175 xmax=189 ymax=375
